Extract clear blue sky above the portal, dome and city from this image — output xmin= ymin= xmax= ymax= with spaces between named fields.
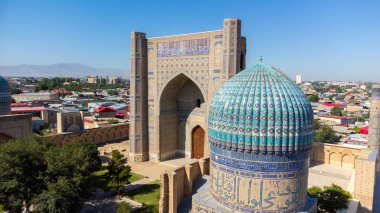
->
xmin=0 ymin=0 xmax=380 ymax=81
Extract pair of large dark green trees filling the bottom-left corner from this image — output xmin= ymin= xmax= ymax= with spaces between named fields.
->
xmin=0 ymin=137 xmax=101 ymax=212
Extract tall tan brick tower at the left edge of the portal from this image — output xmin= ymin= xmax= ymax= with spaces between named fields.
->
xmin=129 ymin=32 xmax=149 ymax=162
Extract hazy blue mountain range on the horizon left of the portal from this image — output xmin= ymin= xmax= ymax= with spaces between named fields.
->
xmin=0 ymin=63 xmax=130 ymax=78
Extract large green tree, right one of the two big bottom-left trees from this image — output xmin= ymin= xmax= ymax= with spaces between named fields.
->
xmin=34 ymin=142 xmax=101 ymax=213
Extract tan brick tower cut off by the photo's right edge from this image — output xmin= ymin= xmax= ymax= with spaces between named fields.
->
xmin=368 ymin=84 xmax=380 ymax=150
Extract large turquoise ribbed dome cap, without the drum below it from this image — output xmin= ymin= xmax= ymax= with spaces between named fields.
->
xmin=208 ymin=63 xmax=313 ymax=155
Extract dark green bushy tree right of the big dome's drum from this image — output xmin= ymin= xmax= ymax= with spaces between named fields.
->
xmin=308 ymin=184 xmax=352 ymax=213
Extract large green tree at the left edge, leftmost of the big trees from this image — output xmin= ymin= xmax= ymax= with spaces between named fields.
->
xmin=0 ymin=137 xmax=52 ymax=212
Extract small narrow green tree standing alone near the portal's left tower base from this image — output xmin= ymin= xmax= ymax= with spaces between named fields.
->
xmin=107 ymin=150 xmax=132 ymax=195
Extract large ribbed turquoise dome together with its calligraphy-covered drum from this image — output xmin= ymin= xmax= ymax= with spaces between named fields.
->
xmin=208 ymin=63 xmax=313 ymax=212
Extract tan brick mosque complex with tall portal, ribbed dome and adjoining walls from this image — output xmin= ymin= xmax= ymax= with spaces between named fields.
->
xmin=129 ymin=18 xmax=380 ymax=213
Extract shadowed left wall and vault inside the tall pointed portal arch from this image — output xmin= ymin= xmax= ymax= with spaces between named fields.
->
xmin=159 ymin=74 xmax=204 ymax=160
